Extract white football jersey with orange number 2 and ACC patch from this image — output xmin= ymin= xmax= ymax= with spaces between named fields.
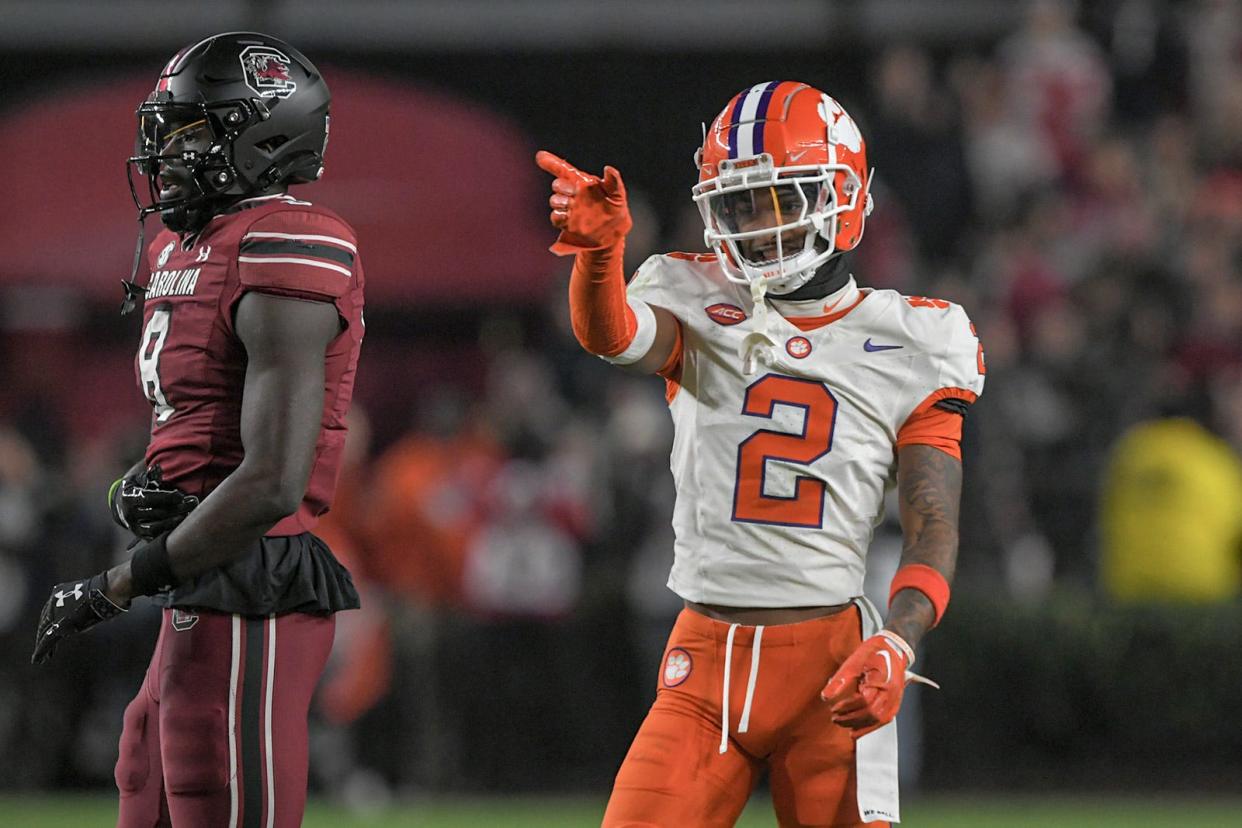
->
xmin=628 ymin=253 xmax=984 ymax=607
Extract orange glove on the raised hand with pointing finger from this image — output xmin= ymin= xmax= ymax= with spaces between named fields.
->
xmin=535 ymin=150 xmax=633 ymax=256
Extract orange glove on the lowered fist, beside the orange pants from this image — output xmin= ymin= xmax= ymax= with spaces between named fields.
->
xmin=820 ymin=629 xmax=939 ymax=739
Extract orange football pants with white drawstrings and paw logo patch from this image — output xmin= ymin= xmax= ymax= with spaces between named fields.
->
xmin=604 ymin=606 xmax=888 ymax=828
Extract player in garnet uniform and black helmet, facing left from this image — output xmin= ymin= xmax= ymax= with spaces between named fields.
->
xmin=34 ymin=32 xmax=364 ymax=828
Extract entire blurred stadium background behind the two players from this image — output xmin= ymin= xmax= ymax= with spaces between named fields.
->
xmin=0 ymin=0 xmax=1242 ymax=826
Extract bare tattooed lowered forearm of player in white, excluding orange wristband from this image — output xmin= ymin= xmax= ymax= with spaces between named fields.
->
xmin=884 ymin=444 xmax=961 ymax=647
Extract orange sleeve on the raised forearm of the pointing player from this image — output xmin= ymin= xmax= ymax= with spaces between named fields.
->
xmin=569 ymin=240 xmax=638 ymax=356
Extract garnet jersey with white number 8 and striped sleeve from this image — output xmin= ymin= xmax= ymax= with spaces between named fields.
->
xmin=135 ymin=195 xmax=364 ymax=535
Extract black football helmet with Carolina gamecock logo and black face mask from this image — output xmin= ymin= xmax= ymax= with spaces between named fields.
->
xmin=128 ymin=32 xmax=332 ymax=232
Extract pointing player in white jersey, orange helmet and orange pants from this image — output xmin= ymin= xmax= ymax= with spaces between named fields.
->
xmin=537 ymin=81 xmax=984 ymax=827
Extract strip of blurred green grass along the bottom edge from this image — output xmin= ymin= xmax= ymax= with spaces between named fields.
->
xmin=0 ymin=796 xmax=1242 ymax=828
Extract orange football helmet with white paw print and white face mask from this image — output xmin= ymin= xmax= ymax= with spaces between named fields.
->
xmin=693 ymin=81 xmax=871 ymax=294
